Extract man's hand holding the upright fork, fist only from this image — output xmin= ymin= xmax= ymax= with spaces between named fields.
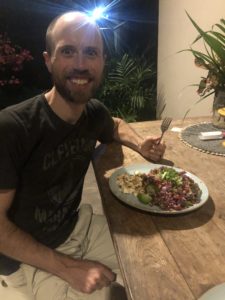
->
xmin=138 ymin=136 xmax=166 ymax=162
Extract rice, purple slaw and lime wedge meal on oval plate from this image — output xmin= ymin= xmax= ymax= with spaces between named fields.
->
xmin=116 ymin=166 xmax=201 ymax=210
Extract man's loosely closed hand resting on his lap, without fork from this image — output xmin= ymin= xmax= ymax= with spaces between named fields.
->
xmin=56 ymin=255 xmax=116 ymax=294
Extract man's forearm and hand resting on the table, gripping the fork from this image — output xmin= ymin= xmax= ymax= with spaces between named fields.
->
xmin=113 ymin=118 xmax=166 ymax=161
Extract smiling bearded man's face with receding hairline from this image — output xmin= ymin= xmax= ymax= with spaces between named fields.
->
xmin=45 ymin=17 xmax=104 ymax=104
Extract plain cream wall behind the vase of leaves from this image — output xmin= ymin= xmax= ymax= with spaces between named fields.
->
xmin=157 ymin=0 xmax=225 ymax=118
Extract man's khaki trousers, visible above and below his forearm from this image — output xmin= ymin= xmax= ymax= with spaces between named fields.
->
xmin=22 ymin=205 xmax=126 ymax=300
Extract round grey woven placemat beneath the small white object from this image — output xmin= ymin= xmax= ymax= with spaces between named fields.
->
xmin=180 ymin=123 xmax=225 ymax=156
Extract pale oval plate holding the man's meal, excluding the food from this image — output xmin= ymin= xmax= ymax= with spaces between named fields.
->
xmin=109 ymin=163 xmax=209 ymax=215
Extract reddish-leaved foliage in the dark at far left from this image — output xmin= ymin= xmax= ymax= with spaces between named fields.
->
xmin=0 ymin=33 xmax=33 ymax=87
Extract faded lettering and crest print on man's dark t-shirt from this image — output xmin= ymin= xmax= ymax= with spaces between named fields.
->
xmin=34 ymin=138 xmax=96 ymax=232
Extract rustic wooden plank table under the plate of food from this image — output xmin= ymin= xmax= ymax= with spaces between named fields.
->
xmin=93 ymin=118 xmax=225 ymax=300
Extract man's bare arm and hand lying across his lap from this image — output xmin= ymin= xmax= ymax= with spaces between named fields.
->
xmin=0 ymin=190 xmax=115 ymax=293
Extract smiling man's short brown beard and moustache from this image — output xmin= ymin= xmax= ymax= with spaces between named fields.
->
xmin=52 ymin=71 xmax=102 ymax=104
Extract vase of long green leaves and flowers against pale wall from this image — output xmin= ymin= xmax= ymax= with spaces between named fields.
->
xmin=184 ymin=13 xmax=225 ymax=128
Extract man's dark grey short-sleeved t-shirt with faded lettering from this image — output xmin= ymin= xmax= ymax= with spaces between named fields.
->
xmin=0 ymin=95 xmax=114 ymax=275
